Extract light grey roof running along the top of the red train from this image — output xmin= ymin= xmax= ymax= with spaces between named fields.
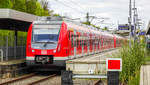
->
xmin=33 ymin=16 xmax=119 ymax=38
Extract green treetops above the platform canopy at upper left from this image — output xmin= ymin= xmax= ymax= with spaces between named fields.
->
xmin=0 ymin=0 xmax=53 ymax=16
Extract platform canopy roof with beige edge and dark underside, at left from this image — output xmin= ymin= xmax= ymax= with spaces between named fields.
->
xmin=0 ymin=9 xmax=38 ymax=31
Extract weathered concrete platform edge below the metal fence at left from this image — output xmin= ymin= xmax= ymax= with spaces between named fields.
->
xmin=0 ymin=59 xmax=27 ymax=78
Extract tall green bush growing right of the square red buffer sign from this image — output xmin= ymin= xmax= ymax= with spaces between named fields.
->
xmin=120 ymin=42 xmax=146 ymax=85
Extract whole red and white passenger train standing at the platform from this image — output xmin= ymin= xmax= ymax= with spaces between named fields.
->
xmin=26 ymin=17 xmax=125 ymax=66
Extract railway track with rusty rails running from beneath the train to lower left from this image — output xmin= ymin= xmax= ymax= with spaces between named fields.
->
xmin=0 ymin=73 xmax=57 ymax=85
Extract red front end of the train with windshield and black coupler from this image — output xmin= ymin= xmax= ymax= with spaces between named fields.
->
xmin=26 ymin=17 xmax=67 ymax=66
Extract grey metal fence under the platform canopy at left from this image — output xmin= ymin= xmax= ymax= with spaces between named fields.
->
xmin=0 ymin=36 xmax=26 ymax=62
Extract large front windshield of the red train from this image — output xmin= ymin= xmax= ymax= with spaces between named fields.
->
xmin=32 ymin=25 xmax=60 ymax=42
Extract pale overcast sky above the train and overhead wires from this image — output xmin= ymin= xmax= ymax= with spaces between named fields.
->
xmin=49 ymin=0 xmax=150 ymax=27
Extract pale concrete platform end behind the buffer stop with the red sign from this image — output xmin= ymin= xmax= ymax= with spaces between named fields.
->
xmin=66 ymin=49 xmax=119 ymax=77
